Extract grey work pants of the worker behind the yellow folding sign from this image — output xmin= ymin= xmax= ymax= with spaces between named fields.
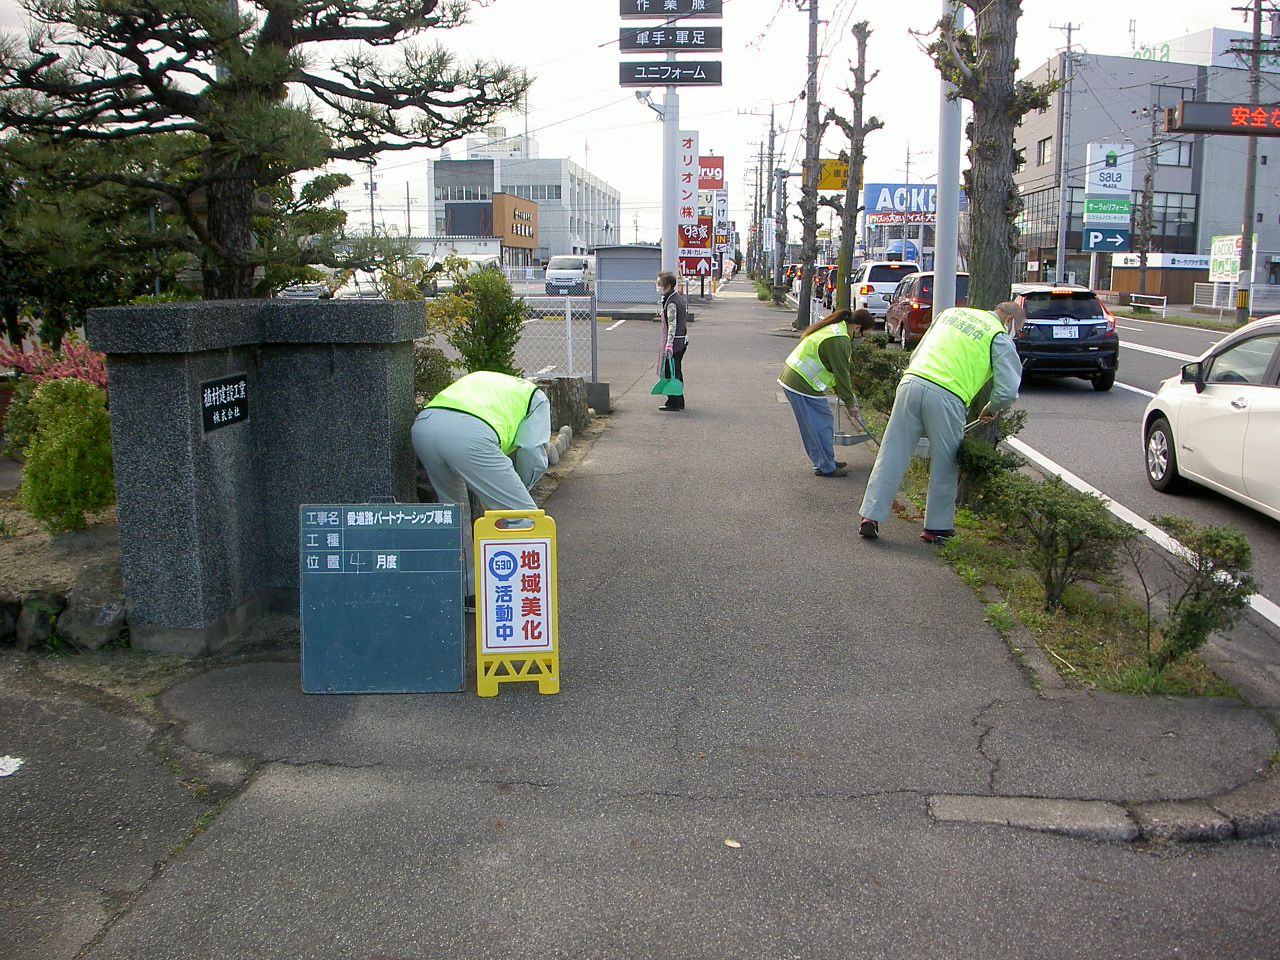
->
xmin=411 ymin=407 xmax=538 ymax=594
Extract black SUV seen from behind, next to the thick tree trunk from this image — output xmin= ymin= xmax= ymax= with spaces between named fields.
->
xmin=1012 ymin=283 xmax=1120 ymax=390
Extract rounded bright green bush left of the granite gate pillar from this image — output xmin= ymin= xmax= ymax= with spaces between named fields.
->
xmin=18 ymin=378 xmax=115 ymax=532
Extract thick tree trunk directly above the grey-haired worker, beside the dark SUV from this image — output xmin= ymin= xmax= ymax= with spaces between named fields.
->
xmin=966 ymin=0 xmax=1023 ymax=310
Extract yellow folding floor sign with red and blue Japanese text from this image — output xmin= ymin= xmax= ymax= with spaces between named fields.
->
xmin=475 ymin=509 xmax=559 ymax=696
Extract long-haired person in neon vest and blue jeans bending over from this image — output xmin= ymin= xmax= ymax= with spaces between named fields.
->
xmin=778 ymin=310 xmax=874 ymax=476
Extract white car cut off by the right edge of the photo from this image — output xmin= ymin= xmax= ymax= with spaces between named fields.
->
xmin=1142 ymin=315 xmax=1280 ymax=520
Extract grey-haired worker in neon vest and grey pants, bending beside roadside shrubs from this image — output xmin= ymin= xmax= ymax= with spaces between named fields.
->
xmin=858 ymin=302 xmax=1027 ymax=543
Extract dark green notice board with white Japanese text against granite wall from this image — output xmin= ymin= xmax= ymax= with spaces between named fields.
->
xmin=298 ymin=503 xmax=466 ymax=694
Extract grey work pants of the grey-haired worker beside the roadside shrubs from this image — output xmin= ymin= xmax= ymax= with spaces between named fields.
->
xmin=861 ymin=375 xmax=968 ymax=530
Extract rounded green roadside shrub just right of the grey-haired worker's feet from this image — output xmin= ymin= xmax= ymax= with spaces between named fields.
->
xmin=995 ymin=474 xmax=1137 ymax=611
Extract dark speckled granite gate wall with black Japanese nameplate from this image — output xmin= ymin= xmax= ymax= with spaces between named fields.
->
xmin=86 ymin=300 xmax=426 ymax=653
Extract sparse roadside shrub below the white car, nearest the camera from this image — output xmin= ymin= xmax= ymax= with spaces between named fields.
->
xmin=1151 ymin=515 xmax=1258 ymax=672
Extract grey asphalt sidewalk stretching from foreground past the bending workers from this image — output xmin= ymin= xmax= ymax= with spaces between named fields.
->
xmin=0 ymin=280 xmax=1280 ymax=960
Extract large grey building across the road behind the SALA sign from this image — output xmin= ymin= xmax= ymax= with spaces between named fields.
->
xmin=1014 ymin=28 xmax=1280 ymax=288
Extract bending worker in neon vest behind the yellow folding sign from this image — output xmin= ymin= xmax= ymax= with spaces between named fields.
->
xmin=412 ymin=371 xmax=552 ymax=598
